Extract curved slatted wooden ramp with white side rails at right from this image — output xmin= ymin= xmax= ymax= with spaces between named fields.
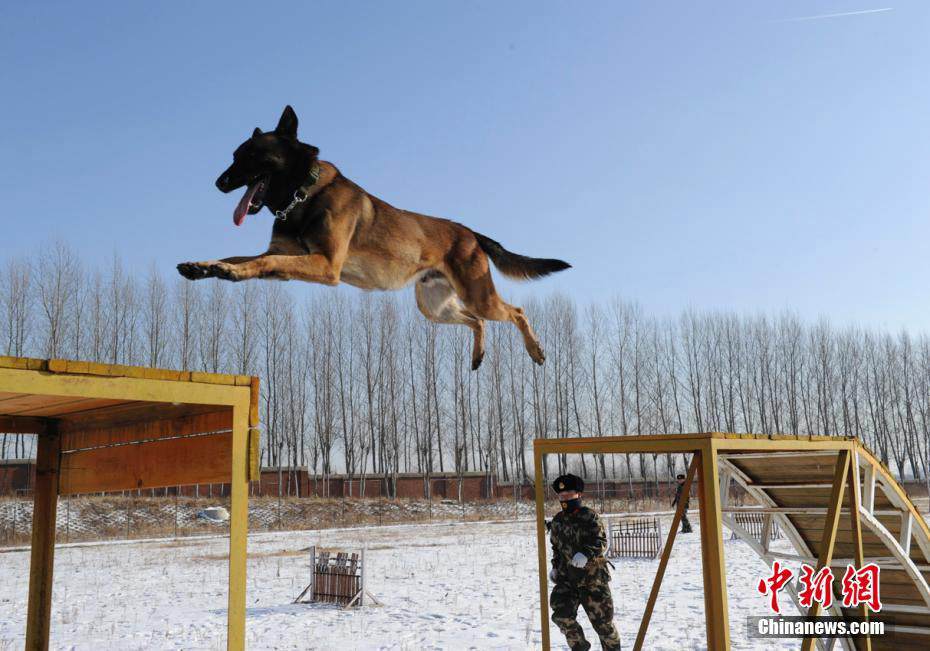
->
xmin=718 ymin=441 xmax=930 ymax=649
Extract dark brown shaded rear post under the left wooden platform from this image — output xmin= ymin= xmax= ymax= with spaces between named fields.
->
xmin=26 ymin=421 xmax=61 ymax=651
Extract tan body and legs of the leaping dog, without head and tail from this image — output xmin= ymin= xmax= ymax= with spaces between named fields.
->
xmin=179 ymin=161 xmax=545 ymax=368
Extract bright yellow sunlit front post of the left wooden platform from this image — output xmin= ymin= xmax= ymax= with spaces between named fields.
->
xmin=226 ymin=399 xmax=249 ymax=651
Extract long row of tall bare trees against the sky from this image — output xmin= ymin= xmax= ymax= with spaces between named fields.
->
xmin=0 ymin=244 xmax=930 ymax=494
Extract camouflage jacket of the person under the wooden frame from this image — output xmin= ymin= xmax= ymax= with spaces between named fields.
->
xmin=549 ymin=506 xmax=610 ymax=583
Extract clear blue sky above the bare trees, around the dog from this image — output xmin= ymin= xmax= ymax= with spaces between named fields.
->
xmin=0 ymin=0 xmax=930 ymax=331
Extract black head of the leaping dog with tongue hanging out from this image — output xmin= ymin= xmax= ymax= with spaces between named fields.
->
xmin=216 ymin=106 xmax=320 ymax=226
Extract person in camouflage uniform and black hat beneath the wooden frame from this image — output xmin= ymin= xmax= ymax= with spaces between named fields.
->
xmin=549 ymin=475 xmax=620 ymax=651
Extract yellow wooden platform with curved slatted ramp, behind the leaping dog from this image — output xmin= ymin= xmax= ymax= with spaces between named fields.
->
xmin=533 ymin=432 xmax=930 ymax=651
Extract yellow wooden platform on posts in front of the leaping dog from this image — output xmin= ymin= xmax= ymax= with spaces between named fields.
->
xmin=0 ymin=357 xmax=259 ymax=651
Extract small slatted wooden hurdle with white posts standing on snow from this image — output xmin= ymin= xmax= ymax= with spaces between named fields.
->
xmin=293 ymin=546 xmax=381 ymax=608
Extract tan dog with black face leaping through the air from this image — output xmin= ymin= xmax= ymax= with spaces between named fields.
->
xmin=178 ymin=106 xmax=571 ymax=369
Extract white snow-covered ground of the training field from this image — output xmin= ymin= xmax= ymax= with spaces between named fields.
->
xmin=0 ymin=514 xmax=798 ymax=651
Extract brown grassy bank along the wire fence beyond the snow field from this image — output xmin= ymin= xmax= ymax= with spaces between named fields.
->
xmin=0 ymin=484 xmax=724 ymax=546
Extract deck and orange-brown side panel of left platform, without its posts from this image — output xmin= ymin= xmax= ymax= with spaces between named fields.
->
xmin=0 ymin=357 xmax=259 ymax=494
